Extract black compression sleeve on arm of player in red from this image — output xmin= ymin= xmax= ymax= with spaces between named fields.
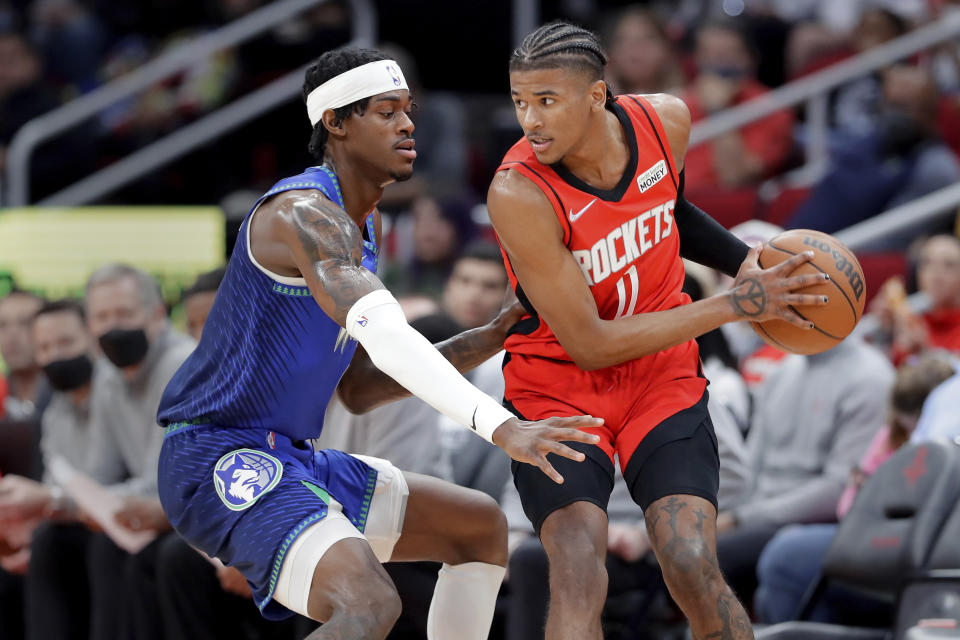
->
xmin=673 ymin=171 xmax=749 ymax=277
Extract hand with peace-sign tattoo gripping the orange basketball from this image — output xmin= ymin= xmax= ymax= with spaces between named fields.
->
xmin=729 ymin=245 xmax=830 ymax=329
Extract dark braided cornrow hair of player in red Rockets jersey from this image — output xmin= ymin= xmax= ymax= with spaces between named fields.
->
xmin=510 ymin=21 xmax=613 ymax=100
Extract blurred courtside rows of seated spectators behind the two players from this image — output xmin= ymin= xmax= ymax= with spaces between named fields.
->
xmin=0 ymin=228 xmax=960 ymax=640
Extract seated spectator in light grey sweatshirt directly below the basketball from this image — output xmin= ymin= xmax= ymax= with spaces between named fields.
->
xmin=717 ymin=338 xmax=894 ymax=602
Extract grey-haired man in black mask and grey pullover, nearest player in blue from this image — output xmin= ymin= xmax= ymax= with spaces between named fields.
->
xmin=27 ymin=264 xmax=194 ymax=640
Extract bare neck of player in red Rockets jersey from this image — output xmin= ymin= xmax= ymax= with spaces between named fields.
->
xmin=562 ymin=109 xmax=630 ymax=189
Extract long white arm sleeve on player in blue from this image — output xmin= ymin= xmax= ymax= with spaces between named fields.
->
xmin=346 ymin=289 xmax=515 ymax=442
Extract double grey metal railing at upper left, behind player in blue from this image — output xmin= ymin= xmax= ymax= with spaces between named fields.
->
xmin=6 ymin=0 xmax=376 ymax=206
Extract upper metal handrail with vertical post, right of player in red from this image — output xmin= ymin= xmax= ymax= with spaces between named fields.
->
xmin=690 ymin=14 xmax=960 ymax=163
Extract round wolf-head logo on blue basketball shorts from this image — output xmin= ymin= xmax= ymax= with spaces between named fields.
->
xmin=213 ymin=449 xmax=283 ymax=511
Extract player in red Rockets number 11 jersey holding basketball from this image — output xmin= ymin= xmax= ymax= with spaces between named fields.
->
xmin=487 ymin=23 xmax=825 ymax=640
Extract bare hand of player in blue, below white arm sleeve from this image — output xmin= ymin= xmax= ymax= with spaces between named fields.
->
xmin=493 ymin=416 xmax=603 ymax=484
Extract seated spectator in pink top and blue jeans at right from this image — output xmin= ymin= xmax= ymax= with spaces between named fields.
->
xmin=755 ymin=356 xmax=953 ymax=626
